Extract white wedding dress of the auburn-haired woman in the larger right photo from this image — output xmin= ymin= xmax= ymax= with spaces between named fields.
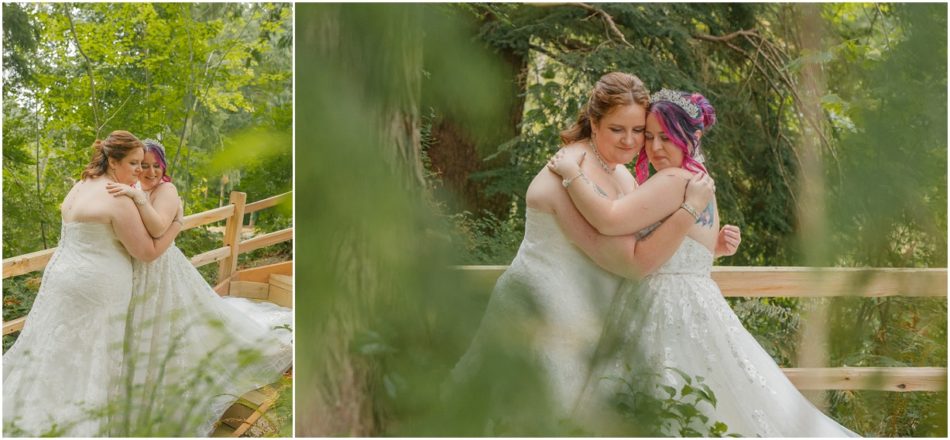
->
xmin=452 ymin=208 xmax=622 ymax=419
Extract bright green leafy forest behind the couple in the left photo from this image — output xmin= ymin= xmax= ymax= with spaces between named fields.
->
xmin=2 ymin=3 xmax=293 ymax=435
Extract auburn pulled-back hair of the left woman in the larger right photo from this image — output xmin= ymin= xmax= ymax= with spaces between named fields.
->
xmin=561 ymin=72 xmax=650 ymax=145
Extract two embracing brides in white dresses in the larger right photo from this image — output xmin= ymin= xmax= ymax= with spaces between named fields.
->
xmin=452 ymin=72 xmax=855 ymax=437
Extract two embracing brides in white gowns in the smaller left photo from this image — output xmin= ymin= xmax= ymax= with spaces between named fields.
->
xmin=3 ymin=131 xmax=292 ymax=437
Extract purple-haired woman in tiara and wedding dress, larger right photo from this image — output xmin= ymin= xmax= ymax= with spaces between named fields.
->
xmin=550 ymin=89 xmax=857 ymax=437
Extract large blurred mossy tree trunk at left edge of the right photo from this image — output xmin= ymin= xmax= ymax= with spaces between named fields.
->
xmin=297 ymin=5 xmax=423 ymax=436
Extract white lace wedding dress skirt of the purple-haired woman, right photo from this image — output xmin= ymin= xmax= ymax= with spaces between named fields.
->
xmin=577 ymin=237 xmax=856 ymax=437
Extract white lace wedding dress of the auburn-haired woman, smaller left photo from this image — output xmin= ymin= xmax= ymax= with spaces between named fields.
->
xmin=3 ymin=222 xmax=132 ymax=437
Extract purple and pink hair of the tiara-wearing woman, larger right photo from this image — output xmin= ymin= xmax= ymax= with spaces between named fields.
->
xmin=634 ymin=92 xmax=716 ymax=183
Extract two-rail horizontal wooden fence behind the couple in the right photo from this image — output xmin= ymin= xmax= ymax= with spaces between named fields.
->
xmin=457 ymin=266 xmax=947 ymax=392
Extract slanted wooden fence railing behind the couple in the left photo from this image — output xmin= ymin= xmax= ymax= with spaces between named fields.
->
xmin=3 ymin=191 xmax=294 ymax=335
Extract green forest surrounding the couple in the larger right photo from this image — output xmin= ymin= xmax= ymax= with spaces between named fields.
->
xmin=296 ymin=3 xmax=947 ymax=436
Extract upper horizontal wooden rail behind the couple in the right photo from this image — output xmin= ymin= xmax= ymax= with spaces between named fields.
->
xmin=454 ymin=266 xmax=947 ymax=297
